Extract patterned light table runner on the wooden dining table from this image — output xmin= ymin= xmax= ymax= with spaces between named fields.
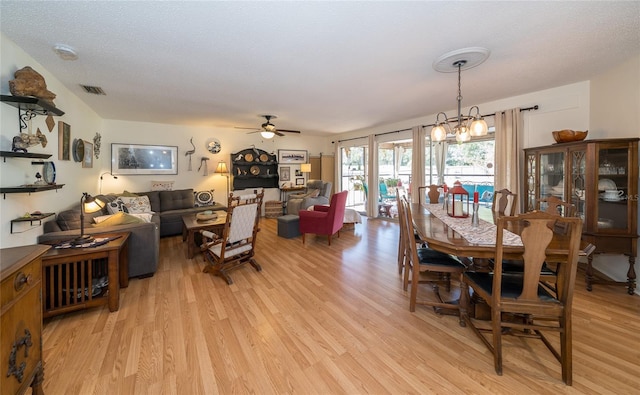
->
xmin=425 ymin=204 xmax=522 ymax=246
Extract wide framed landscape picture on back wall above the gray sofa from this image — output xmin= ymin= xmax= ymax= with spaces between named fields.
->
xmin=111 ymin=143 xmax=178 ymax=175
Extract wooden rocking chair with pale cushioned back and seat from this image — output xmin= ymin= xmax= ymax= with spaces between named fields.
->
xmin=200 ymin=190 xmax=264 ymax=285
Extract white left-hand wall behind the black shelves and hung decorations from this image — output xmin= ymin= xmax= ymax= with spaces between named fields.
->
xmin=0 ymin=35 xmax=105 ymax=248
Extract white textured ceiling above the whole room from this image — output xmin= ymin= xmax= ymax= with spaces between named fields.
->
xmin=0 ymin=0 xmax=640 ymax=134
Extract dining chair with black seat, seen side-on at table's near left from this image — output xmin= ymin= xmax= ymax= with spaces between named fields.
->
xmin=400 ymin=197 xmax=466 ymax=325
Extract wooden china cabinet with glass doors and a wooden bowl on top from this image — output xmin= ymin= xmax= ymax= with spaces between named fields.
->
xmin=524 ymin=138 xmax=640 ymax=295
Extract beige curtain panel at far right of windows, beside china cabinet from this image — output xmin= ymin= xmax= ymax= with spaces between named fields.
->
xmin=494 ymin=108 xmax=524 ymax=212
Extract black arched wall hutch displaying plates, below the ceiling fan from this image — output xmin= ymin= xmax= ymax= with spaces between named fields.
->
xmin=231 ymin=148 xmax=280 ymax=190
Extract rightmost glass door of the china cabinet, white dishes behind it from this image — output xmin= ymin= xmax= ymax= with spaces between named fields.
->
xmin=597 ymin=144 xmax=634 ymax=231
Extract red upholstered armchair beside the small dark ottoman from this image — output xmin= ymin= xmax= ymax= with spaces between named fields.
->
xmin=298 ymin=191 xmax=348 ymax=245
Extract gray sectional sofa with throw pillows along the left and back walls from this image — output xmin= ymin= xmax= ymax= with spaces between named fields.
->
xmin=38 ymin=189 xmax=226 ymax=277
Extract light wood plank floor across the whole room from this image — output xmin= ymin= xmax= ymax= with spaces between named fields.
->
xmin=38 ymin=219 xmax=640 ymax=395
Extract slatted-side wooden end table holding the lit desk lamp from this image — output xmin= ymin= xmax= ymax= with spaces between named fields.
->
xmin=42 ymin=232 xmax=129 ymax=317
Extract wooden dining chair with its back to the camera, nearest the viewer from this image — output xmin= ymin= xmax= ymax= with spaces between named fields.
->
xmin=460 ymin=211 xmax=582 ymax=385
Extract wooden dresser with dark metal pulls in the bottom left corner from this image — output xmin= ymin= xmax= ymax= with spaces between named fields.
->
xmin=0 ymin=245 xmax=51 ymax=395
